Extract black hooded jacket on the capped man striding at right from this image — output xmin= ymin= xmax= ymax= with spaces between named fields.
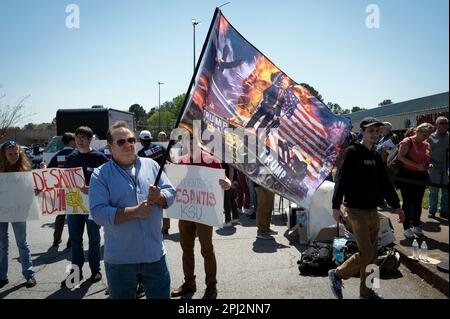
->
xmin=333 ymin=143 xmax=400 ymax=209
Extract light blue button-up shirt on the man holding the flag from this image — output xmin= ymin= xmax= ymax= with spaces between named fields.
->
xmin=89 ymin=157 xmax=176 ymax=264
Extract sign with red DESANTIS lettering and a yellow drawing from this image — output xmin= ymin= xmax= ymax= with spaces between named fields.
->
xmin=32 ymin=167 xmax=89 ymax=215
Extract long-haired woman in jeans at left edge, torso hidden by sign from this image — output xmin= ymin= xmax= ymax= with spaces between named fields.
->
xmin=0 ymin=141 xmax=36 ymax=288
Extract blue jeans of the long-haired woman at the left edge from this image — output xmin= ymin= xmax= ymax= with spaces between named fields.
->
xmin=0 ymin=222 xmax=34 ymax=280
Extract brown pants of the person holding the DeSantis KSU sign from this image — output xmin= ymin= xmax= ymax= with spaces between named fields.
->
xmin=178 ymin=220 xmax=217 ymax=288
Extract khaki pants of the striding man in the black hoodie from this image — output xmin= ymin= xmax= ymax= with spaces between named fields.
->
xmin=336 ymin=208 xmax=380 ymax=296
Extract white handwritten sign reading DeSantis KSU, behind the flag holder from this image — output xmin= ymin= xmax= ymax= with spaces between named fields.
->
xmin=164 ymin=164 xmax=225 ymax=228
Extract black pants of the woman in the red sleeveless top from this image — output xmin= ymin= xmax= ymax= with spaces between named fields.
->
xmin=398 ymin=168 xmax=429 ymax=230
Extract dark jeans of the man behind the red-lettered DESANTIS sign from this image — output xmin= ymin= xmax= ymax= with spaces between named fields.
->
xmin=67 ymin=215 xmax=100 ymax=274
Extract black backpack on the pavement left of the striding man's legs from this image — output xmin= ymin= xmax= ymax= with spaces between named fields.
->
xmin=297 ymin=242 xmax=336 ymax=276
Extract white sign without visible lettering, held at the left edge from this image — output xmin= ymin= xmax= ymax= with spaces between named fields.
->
xmin=0 ymin=172 xmax=40 ymax=222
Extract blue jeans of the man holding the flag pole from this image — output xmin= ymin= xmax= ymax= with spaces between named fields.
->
xmin=105 ymin=256 xmax=170 ymax=299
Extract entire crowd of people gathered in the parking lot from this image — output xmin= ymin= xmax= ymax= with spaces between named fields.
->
xmin=0 ymin=117 xmax=449 ymax=299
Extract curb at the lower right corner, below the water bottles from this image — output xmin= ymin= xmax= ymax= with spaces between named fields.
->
xmin=394 ymin=245 xmax=449 ymax=298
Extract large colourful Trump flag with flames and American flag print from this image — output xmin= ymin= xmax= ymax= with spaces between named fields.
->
xmin=179 ymin=9 xmax=351 ymax=204
